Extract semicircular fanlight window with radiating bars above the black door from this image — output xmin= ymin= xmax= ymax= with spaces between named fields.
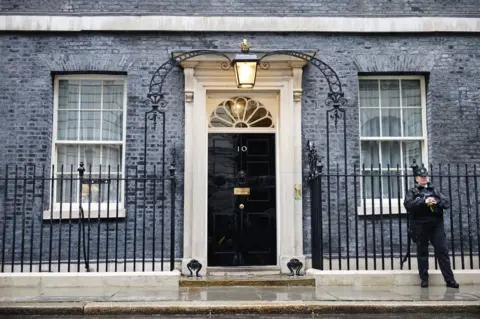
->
xmin=209 ymin=97 xmax=274 ymax=128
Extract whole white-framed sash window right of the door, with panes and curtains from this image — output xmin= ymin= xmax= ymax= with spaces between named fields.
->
xmin=358 ymin=76 xmax=428 ymax=210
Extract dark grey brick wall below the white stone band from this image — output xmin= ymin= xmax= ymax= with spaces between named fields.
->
xmin=0 ymin=33 xmax=480 ymax=268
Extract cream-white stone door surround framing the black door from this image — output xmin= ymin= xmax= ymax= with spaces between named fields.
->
xmin=178 ymin=54 xmax=307 ymax=274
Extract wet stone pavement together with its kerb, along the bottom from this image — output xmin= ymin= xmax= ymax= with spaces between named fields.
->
xmin=0 ymin=286 xmax=480 ymax=319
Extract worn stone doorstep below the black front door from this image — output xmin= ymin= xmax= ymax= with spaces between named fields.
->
xmin=180 ymin=274 xmax=315 ymax=287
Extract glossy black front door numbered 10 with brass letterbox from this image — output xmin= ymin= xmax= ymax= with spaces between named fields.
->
xmin=208 ymin=133 xmax=277 ymax=266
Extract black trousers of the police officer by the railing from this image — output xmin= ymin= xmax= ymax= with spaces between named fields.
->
xmin=415 ymin=220 xmax=454 ymax=282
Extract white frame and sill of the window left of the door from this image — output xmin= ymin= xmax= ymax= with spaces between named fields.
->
xmin=43 ymin=74 xmax=127 ymax=219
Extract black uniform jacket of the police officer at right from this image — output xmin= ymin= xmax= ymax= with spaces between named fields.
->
xmin=403 ymin=183 xmax=450 ymax=222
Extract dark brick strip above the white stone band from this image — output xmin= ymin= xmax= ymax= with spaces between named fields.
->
xmin=0 ymin=0 xmax=480 ymax=17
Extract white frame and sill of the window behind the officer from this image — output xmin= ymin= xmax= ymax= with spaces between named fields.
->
xmin=357 ymin=75 xmax=428 ymax=216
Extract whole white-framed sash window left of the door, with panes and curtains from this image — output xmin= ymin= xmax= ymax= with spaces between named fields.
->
xmin=48 ymin=75 xmax=127 ymax=218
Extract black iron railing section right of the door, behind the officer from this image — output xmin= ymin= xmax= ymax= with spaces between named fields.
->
xmin=309 ymin=164 xmax=480 ymax=270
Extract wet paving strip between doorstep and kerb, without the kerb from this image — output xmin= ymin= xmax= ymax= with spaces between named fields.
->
xmin=0 ymin=285 xmax=480 ymax=302
